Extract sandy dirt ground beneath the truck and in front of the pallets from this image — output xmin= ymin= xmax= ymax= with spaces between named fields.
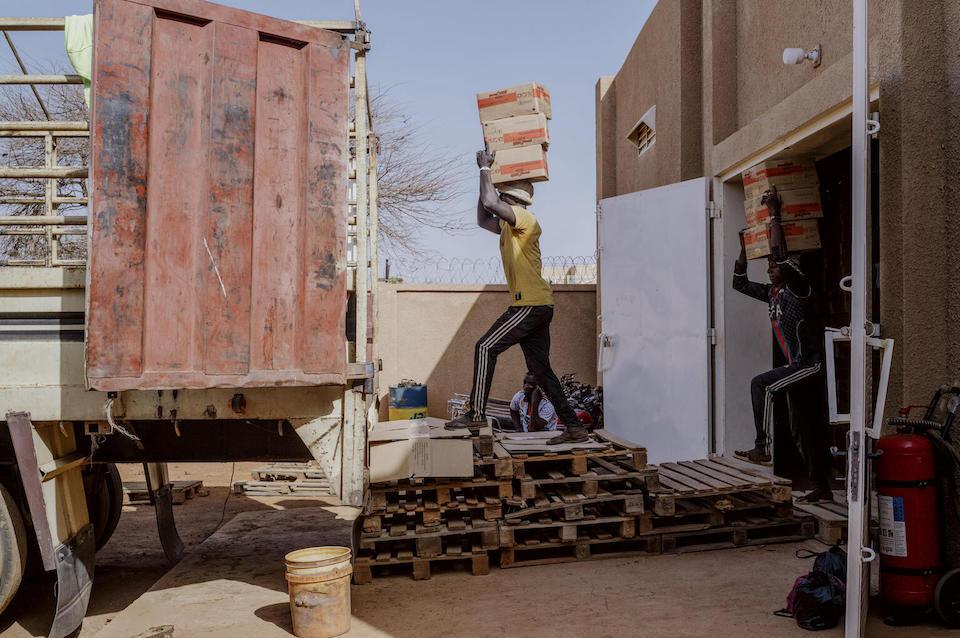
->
xmin=0 ymin=463 xmax=949 ymax=638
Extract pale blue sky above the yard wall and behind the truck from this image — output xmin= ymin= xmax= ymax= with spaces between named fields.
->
xmin=0 ymin=0 xmax=656 ymax=257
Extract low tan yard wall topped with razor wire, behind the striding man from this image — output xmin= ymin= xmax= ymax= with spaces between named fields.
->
xmin=377 ymin=282 xmax=597 ymax=418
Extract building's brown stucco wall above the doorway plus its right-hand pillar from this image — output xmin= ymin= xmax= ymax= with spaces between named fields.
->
xmin=598 ymin=0 xmax=960 ymax=418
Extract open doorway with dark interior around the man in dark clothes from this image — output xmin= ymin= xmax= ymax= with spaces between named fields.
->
xmin=714 ymin=118 xmax=880 ymax=489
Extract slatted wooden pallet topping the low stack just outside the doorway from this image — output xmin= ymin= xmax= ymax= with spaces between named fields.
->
xmin=651 ymin=457 xmax=791 ymax=516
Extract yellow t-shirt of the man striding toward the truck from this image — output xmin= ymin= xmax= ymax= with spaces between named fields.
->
xmin=500 ymin=206 xmax=553 ymax=306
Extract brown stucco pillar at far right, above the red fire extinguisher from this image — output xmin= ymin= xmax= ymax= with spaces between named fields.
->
xmin=879 ymin=0 xmax=960 ymax=405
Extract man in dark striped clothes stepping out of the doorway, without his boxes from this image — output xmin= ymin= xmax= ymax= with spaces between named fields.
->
xmin=733 ymin=190 xmax=833 ymax=502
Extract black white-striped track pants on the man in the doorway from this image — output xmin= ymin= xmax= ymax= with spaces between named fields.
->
xmin=750 ymin=363 xmax=831 ymax=485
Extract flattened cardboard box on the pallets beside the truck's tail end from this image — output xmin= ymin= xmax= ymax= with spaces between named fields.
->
xmin=367 ymin=417 xmax=493 ymax=483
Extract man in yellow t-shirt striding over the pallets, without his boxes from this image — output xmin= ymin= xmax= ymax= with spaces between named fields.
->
xmin=447 ymin=151 xmax=589 ymax=444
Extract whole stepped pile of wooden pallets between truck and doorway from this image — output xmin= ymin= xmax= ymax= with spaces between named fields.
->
xmin=354 ymin=430 xmax=814 ymax=584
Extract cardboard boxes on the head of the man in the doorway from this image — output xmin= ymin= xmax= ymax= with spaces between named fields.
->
xmin=743 ymin=159 xmax=823 ymax=259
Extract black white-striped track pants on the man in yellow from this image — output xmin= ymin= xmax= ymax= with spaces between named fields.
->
xmin=467 ymin=306 xmax=580 ymax=427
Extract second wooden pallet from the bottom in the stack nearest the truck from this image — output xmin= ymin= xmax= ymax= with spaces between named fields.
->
xmin=357 ymin=518 xmax=500 ymax=558
